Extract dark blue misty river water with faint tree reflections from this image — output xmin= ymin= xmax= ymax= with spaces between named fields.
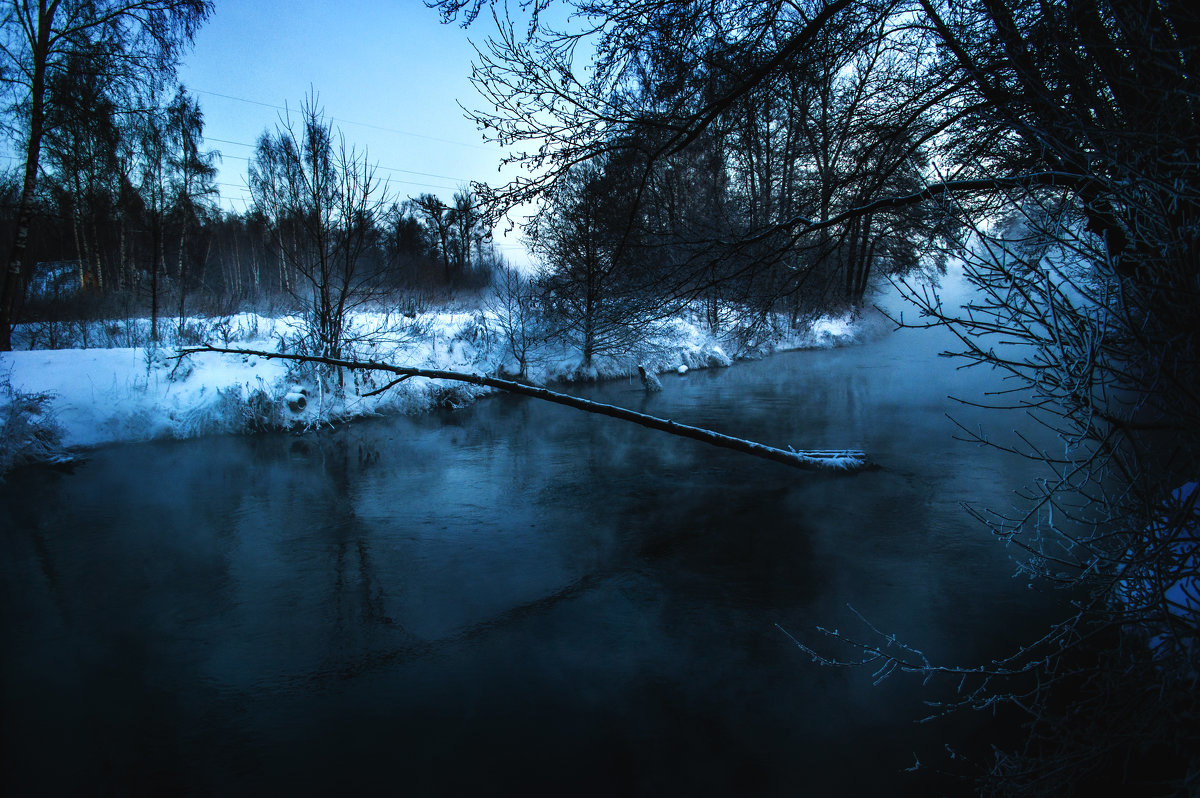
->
xmin=0 ymin=309 xmax=1051 ymax=796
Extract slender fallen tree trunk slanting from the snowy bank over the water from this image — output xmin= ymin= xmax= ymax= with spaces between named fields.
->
xmin=176 ymin=347 xmax=876 ymax=473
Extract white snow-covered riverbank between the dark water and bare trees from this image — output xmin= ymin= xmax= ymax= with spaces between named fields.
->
xmin=0 ymin=303 xmax=872 ymax=473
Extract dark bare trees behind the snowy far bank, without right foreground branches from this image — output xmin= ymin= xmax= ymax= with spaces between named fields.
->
xmin=0 ymin=2 xmax=947 ymax=362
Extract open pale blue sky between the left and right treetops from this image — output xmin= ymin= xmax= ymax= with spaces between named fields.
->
xmin=180 ymin=0 xmax=523 ymax=259
